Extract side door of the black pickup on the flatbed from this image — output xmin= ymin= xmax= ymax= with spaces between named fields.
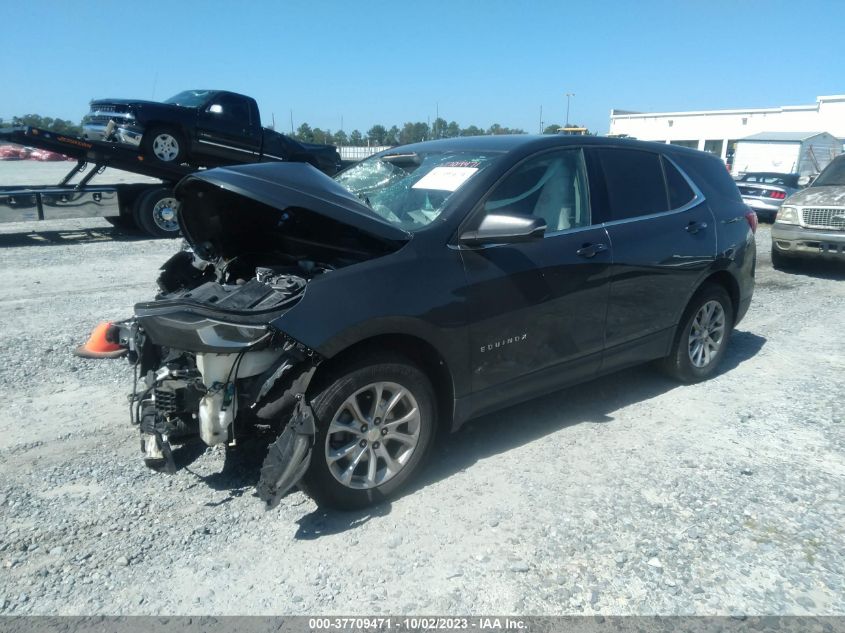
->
xmin=197 ymin=92 xmax=261 ymax=163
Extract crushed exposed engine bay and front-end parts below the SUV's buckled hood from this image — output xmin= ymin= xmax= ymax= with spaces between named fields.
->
xmin=117 ymin=250 xmax=332 ymax=505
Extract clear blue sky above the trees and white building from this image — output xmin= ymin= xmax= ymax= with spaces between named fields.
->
xmin=0 ymin=0 xmax=845 ymax=133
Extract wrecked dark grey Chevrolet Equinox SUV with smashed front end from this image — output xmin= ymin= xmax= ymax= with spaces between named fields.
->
xmin=110 ymin=136 xmax=756 ymax=508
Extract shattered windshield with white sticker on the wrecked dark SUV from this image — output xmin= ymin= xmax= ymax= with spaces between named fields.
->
xmin=335 ymin=148 xmax=499 ymax=231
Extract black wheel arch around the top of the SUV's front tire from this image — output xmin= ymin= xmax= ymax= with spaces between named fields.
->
xmin=309 ymin=333 xmax=455 ymax=431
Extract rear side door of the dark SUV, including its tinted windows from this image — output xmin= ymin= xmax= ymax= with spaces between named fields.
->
xmin=588 ymin=147 xmax=716 ymax=368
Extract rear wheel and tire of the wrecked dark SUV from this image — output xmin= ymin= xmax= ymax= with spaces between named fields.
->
xmin=661 ymin=283 xmax=734 ymax=383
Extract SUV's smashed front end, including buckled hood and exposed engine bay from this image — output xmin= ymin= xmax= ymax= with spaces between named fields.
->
xmin=107 ymin=164 xmax=406 ymax=506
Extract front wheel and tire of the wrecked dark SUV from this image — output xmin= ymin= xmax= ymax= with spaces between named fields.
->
xmin=300 ymin=356 xmax=436 ymax=510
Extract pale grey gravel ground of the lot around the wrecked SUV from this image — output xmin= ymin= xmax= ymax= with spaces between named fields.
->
xmin=0 ymin=215 xmax=845 ymax=615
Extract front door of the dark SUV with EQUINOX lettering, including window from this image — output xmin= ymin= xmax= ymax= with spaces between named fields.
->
xmin=461 ymin=148 xmax=611 ymax=400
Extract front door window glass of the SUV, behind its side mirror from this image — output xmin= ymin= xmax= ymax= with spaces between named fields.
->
xmin=484 ymin=149 xmax=591 ymax=234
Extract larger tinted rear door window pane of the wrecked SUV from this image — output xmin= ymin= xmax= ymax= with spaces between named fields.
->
xmin=598 ymin=149 xmax=669 ymax=221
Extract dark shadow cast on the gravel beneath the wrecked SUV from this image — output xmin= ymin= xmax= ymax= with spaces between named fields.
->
xmin=283 ymin=330 xmax=766 ymax=539
